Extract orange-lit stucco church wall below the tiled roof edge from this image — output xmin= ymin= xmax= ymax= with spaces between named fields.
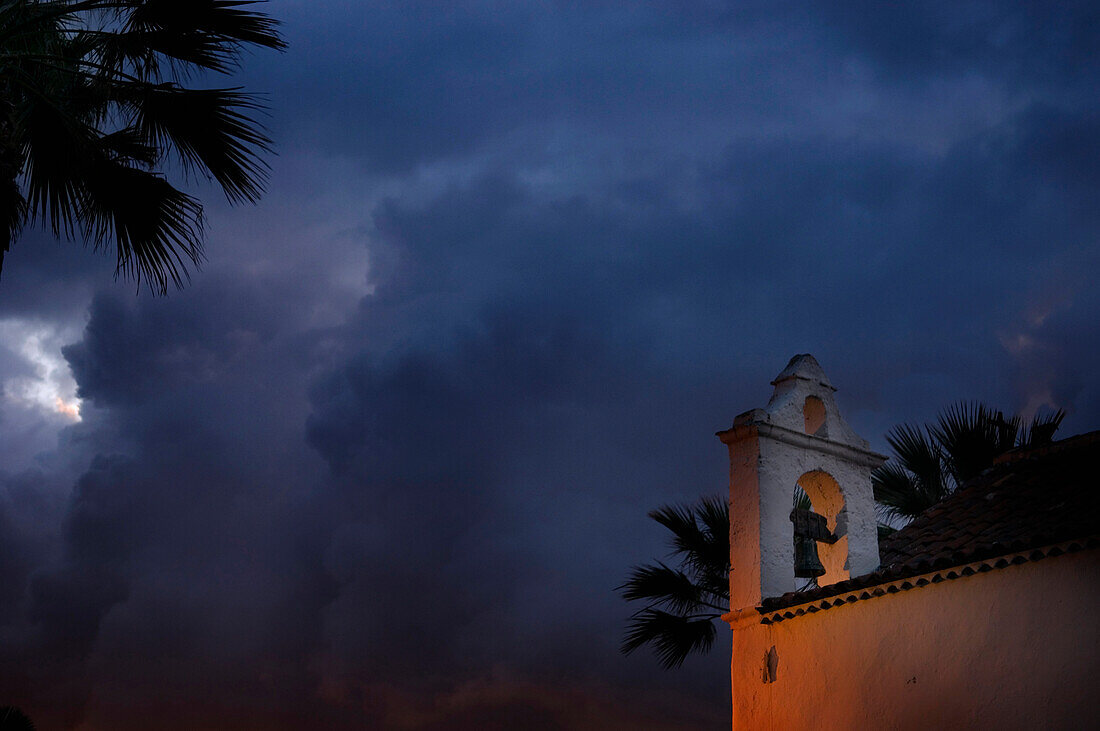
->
xmin=732 ymin=550 xmax=1100 ymax=731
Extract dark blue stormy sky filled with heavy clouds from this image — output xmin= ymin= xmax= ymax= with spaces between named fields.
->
xmin=0 ymin=0 xmax=1100 ymax=730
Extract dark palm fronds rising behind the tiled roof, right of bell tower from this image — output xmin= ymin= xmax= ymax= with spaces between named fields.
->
xmin=871 ymin=401 xmax=1066 ymax=523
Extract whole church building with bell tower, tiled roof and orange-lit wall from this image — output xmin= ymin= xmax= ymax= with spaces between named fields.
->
xmin=718 ymin=355 xmax=1100 ymax=731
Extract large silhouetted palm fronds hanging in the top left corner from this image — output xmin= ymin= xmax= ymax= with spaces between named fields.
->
xmin=0 ymin=0 xmax=285 ymax=293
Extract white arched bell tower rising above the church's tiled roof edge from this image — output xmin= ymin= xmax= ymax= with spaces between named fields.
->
xmin=718 ymin=354 xmax=886 ymax=611
